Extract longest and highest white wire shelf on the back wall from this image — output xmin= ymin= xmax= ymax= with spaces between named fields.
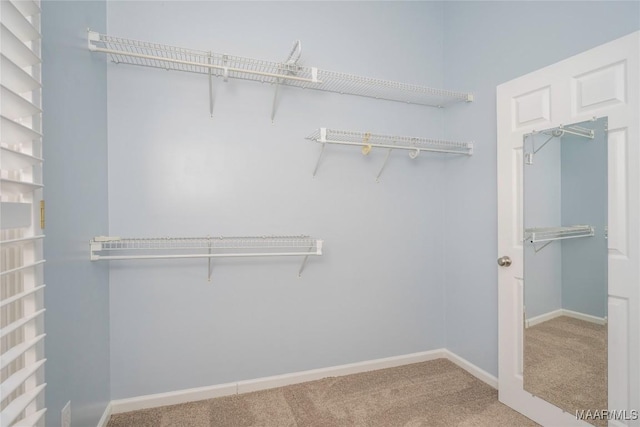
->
xmin=88 ymin=31 xmax=473 ymax=118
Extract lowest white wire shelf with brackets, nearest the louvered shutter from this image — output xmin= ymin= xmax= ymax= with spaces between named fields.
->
xmin=89 ymin=236 xmax=323 ymax=281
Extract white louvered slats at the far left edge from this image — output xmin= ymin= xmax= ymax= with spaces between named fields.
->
xmin=0 ymin=0 xmax=46 ymax=427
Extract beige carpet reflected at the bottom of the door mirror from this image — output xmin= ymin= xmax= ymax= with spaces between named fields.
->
xmin=524 ymin=316 xmax=607 ymax=426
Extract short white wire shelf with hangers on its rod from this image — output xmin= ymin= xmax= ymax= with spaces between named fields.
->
xmin=306 ymin=128 xmax=473 ymax=180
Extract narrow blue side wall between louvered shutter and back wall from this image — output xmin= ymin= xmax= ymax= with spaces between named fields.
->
xmin=42 ymin=1 xmax=110 ymax=426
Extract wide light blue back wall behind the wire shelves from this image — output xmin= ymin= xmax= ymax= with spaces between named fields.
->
xmin=108 ymin=2 xmax=450 ymax=399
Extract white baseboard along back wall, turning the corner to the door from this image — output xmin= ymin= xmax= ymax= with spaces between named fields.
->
xmin=109 ymin=349 xmax=498 ymax=416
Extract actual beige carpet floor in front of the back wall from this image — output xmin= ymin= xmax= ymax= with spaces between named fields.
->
xmin=108 ymin=359 xmax=537 ymax=427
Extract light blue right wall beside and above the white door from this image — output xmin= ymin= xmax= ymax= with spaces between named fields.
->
xmin=444 ymin=1 xmax=640 ymax=375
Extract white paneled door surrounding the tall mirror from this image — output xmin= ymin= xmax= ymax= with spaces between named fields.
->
xmin=497 ymin=32 xmax=640 ymax=426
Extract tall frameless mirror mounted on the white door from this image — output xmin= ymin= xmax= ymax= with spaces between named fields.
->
xmin=523 ymin=117 xmax=607 ymax=426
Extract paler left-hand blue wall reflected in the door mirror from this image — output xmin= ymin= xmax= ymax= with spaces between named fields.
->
xmin=523 ymin=135 xmax=562 ymax=319
